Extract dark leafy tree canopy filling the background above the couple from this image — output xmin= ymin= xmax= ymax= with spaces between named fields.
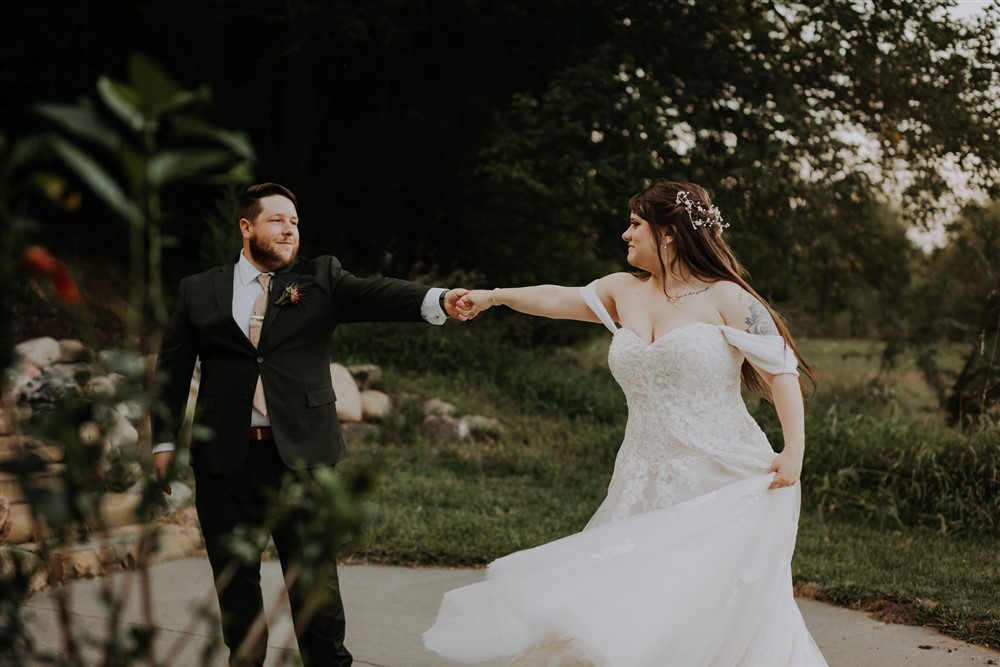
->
xmin=0 ymin=0 xmax=1000 ymax=334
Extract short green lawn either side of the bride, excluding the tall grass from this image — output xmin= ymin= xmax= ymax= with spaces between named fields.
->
xmin=332 ymin=328 xmax=1000 ymax=647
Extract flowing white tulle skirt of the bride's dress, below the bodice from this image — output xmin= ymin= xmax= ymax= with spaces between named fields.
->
xmin=424 ymin=474 xmax=826 ymax=667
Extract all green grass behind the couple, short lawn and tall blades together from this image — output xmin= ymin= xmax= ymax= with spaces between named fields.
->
xmin=332 ymin=330 xmax=1000 ymax=647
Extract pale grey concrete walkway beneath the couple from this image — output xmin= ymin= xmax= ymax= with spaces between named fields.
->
xmin=17 ymin=558 xmax=1000 ymax=667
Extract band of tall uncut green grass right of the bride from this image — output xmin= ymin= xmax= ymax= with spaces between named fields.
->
xmin=771 ymin=405 xmax=1000 ymax=534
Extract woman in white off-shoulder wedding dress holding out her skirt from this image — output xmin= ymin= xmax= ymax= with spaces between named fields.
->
xmin=424 ymin=182 xmax=826 ymax=667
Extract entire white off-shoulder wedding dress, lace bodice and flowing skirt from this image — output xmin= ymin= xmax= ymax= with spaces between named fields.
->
xmin=424 ymin=283 xmax=826 ymax=667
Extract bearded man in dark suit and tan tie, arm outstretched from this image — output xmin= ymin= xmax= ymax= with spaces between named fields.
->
xmin=153 ymin=183 xmax=475 ymax=666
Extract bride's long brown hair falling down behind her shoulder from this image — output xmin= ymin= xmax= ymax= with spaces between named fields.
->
xmin=628 ymin=181 xmax=816 ymax=400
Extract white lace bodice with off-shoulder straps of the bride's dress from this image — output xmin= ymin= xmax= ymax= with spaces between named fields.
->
xmin=581 ymin=283 xmax=796 ymax=526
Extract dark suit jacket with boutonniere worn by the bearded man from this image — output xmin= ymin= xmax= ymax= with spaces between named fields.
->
xmin=153 ymin=256 xmax=429 ymax=474
